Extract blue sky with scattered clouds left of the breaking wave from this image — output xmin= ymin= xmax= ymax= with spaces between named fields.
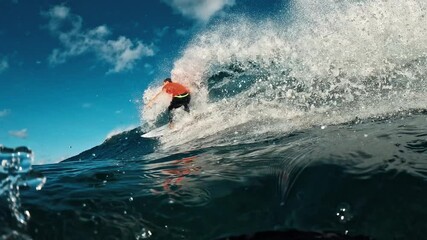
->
xmin=0 ymin=0 xmax=280 ymax=164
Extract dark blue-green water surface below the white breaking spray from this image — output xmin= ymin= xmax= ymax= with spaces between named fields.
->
xmin=0 ymin=114 xmax=427 ymax=239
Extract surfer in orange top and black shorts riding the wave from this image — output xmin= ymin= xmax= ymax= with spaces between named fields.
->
xmin=147 ymin=78 xmax=191 ymax=124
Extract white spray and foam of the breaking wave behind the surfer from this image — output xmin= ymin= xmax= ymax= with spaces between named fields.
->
xmin=142 ymin=0 xmax=427 ymax=150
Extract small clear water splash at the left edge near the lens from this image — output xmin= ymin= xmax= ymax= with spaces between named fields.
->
xmin=0 ymin=146 xmax=46 ymax=231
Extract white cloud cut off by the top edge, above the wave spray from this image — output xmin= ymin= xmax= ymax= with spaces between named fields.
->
xmin=163 ymin=0 xmax=235 ymax=21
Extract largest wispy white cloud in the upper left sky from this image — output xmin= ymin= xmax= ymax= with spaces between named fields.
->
xmin=42 ymin=6 xmax=154 ymax=73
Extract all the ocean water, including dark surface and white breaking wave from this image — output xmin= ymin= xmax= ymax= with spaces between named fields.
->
xmin=0 ymin=0 xmax=427 ymax=239
